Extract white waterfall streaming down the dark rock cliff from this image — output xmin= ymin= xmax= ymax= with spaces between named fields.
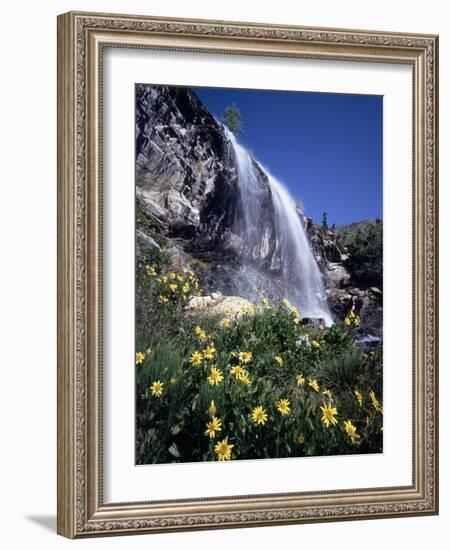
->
xmin=224 ymin=126 xmax=333 ymax=326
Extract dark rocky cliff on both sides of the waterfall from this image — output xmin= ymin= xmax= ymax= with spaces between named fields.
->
xmin=136 ymin=85 xmax=381 ymax=335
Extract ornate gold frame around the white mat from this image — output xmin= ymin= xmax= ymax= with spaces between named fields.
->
xmin=58 ymin=13 xmax=438 ymax=538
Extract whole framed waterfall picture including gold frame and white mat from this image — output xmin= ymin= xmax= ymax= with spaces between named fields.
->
xmin=58 ymin=12 xmax=438 ymax=538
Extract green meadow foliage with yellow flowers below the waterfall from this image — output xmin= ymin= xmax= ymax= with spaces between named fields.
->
xmin=136 ymin=221 xmax=383 ymax=464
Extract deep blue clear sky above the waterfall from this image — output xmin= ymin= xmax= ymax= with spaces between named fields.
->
xmin=193 ymin=88 xmax=383 ymax=225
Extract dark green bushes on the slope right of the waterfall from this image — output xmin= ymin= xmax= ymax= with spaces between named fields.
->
xmin=339 ymin=222 xmax=383 ymax=288
